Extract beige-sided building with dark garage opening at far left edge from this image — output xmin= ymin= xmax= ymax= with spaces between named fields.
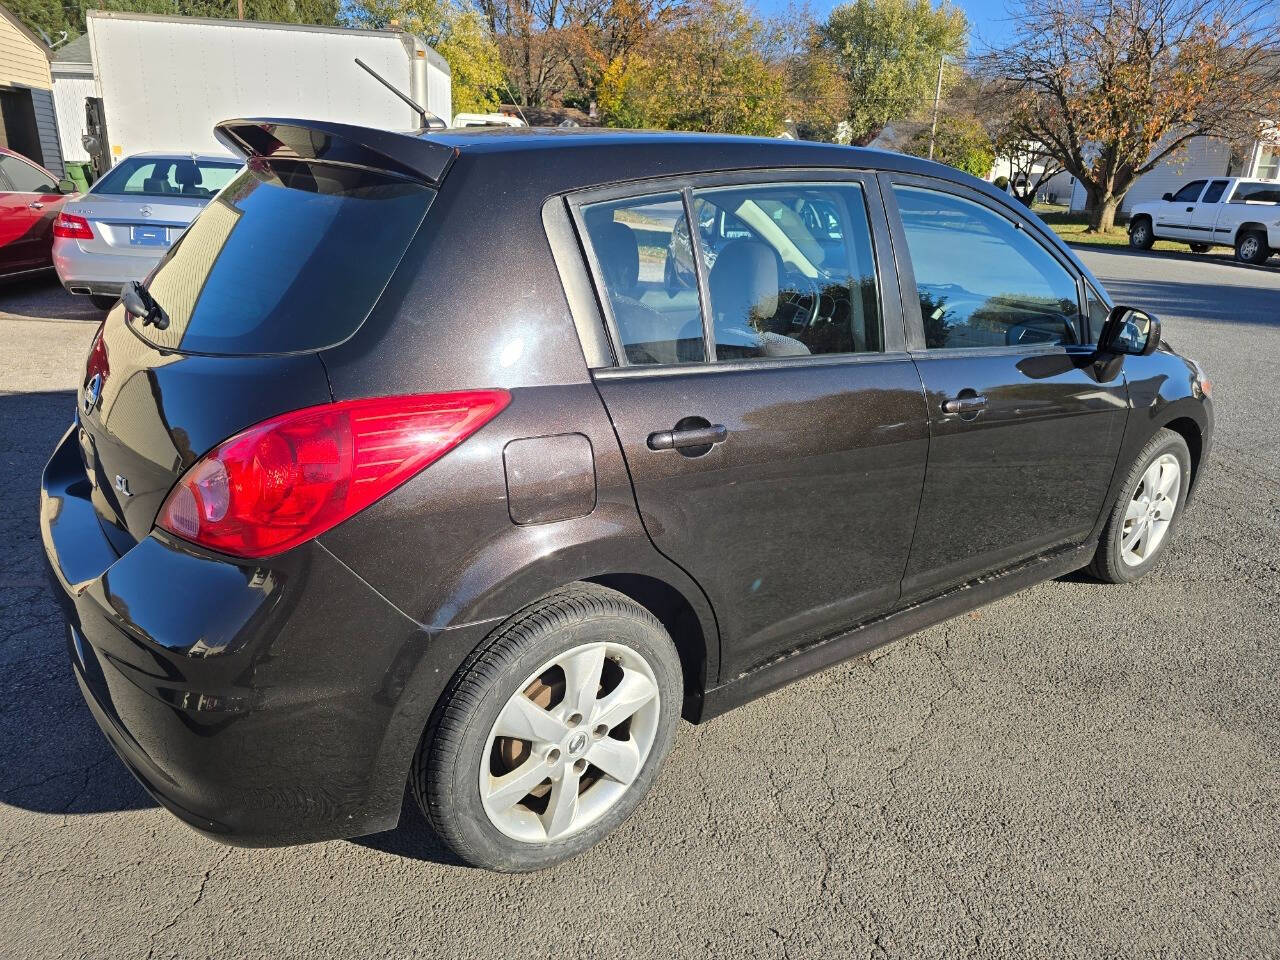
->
xmin=0 ymin=6 xmax=64 ymax=177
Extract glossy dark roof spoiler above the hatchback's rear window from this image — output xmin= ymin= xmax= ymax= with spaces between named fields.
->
xmin=214 ymin=116 xmax=457 ymax=186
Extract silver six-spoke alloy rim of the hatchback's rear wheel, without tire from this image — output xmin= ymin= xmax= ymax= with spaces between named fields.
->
xmin=480 ymin=641 xmax=659 ymax=844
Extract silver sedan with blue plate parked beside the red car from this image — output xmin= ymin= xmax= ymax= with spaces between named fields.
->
xmin=54 ymin=154 xmax=241 ymax=310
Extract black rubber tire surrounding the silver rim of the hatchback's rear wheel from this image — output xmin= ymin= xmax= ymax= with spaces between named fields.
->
xmin=410 ymin=584 xmax=684 ymax=873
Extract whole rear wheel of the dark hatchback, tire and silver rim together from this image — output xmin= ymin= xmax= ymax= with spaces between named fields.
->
xmin=411 ymin=584 xmax=682 ymax=872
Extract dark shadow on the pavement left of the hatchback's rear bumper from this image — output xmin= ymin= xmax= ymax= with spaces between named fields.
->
xmin=0 ymin=390 xmax=155 ymax=814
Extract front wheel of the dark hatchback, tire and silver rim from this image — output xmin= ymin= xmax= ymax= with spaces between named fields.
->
xmin=1089 ymin=429 xmax=1192 ymax=584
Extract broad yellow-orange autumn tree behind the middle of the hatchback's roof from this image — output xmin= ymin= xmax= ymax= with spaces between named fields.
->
xmin=599 ymin=0 xmax=787 ymax=136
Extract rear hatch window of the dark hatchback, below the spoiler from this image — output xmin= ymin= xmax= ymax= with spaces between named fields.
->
xmin=129 ymin=157 xmax=435 ymax=356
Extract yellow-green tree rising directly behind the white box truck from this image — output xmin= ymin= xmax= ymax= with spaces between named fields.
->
xmin=344 ymin=0 xmax=503 ymax=114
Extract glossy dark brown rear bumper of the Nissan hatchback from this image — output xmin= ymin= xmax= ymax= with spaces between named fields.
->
xmin=40 ymin=428 xmax=479 ymax=846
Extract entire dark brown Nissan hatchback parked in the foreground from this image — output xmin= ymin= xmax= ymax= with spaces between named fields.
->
xmin=40 ymin=120 xmax=1213 ymax=870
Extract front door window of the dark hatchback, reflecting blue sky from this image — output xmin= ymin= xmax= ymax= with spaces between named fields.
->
xmin=893 ymin=184 xmax=1080 ymax=348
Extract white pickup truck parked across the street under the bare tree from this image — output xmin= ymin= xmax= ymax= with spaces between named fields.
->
xmin=1129 ymin=177 xmax=1280 ymax=264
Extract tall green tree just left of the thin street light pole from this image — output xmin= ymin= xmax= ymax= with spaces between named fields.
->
xmin=808 ymin=0 xmax=969 ymax=143
